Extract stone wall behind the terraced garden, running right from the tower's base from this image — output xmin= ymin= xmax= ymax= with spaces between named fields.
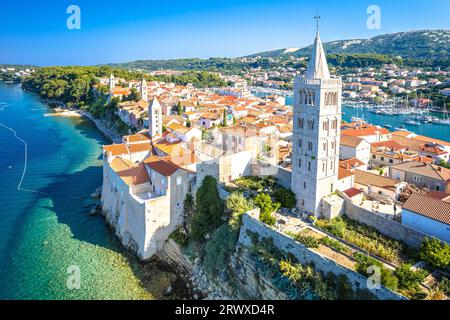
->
xmin=344 ymin=201 xmax=427 ymax=247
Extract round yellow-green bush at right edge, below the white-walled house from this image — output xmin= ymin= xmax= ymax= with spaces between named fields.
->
xmin=420 ymin=238 xmax=450 ymax=269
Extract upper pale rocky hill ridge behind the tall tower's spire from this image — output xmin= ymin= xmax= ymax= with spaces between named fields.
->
xmin=247 ymin=30 xmax=450 ymax=60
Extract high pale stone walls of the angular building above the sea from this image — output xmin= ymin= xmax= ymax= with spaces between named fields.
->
xmin=102 ymin=161 xmax=192 ymax=260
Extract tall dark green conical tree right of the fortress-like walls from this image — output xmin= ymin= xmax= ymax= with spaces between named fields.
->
xmin=191 ymin=176 xmax=224 ymax=241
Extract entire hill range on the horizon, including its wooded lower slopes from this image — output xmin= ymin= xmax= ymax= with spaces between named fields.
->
xmin=104 ymin=30 xmax=450 ymax=74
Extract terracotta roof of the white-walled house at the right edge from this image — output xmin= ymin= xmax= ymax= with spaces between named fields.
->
xmin=403 ymin=193 xmax=450 ymax=225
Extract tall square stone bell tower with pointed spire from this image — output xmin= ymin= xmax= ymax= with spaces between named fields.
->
xmin=291 ymin=31 xmax=342 ymax=217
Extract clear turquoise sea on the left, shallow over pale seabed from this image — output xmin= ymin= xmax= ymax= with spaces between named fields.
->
xmin=0 ymin=81 xmax=153 ymax=299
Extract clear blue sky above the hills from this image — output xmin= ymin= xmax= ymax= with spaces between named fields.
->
xmin=0 ymin=0 xmax=450 ymax=65
